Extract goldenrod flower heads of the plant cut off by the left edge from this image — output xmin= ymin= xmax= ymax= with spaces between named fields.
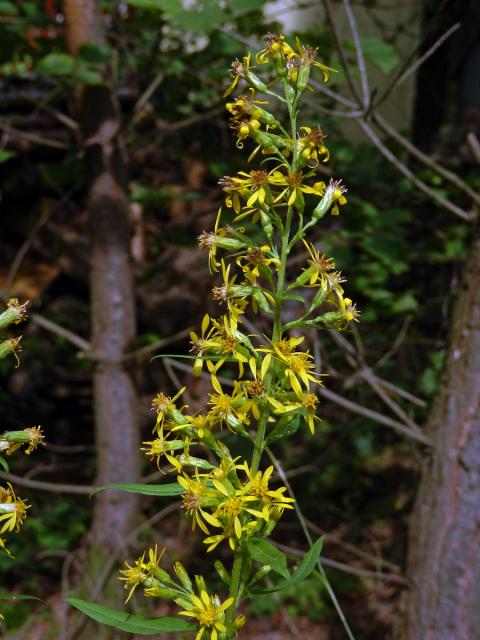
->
xmin=0 ymin=298 xmax=43 ymax=618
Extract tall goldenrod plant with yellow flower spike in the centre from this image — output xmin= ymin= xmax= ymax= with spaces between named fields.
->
xmin=70 ymin=34 xmax=358 ymax=640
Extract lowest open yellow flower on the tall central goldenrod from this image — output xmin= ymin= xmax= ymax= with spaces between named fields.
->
xmin=175 ymin=590 xmax=234 ymax=640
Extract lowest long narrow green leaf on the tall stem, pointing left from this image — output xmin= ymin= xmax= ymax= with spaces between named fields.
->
xmin=67 ymin=598 xmax=195 ymax=636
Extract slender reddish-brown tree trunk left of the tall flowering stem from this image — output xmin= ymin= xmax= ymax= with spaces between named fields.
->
xmin=63 ymin=0 xmax=140 ymax=554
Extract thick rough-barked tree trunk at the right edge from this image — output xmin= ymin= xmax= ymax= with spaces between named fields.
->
xmin=406 ymin=232 xmax=480 ymax=640
